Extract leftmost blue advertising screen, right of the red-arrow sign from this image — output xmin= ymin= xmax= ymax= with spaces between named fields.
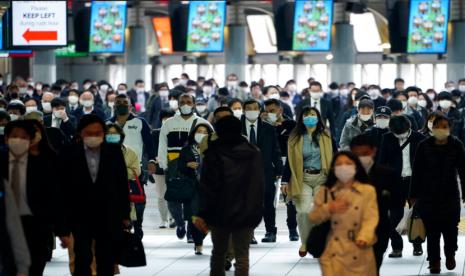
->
xmin=89 ymin=1 xmax=127 ymax=54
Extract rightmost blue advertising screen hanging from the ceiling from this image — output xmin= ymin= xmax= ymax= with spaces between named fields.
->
xmin=407 ymin=0 xmax=449 ymax=54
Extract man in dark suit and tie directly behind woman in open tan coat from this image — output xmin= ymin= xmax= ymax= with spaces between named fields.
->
xmin=295 ymin=81 xmax=336 ymax=137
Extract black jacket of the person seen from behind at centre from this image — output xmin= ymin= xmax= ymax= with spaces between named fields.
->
xmin=199 ymin=138 xmax=265 ymax=229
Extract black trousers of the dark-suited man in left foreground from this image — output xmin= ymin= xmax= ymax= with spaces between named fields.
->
xmin=73 ymin=229 xmax=118 ymax=276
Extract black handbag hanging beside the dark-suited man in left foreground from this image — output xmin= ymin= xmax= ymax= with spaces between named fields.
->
xmin=118 ymin=231 xmax=147 ymax=267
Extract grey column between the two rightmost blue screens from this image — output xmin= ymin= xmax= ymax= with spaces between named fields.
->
xmin=331 ymin=23 xmax=356 ymax=83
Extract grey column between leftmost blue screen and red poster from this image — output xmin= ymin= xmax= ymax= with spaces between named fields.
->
xmin=126 ymin=26 xmax=151 ymax=87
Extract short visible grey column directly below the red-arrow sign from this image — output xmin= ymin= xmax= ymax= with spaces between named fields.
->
xmin=32 ymin=49 xmax=57 ymax=84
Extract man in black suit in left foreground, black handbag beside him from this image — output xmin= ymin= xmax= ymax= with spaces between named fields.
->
xmin=56 ymin=115 xmax=130 ymax=275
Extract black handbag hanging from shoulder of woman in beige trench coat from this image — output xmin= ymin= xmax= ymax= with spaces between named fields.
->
xmin=307 ymin=188 xmax=334 ymax=258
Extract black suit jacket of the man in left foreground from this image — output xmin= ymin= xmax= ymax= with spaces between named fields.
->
xmin=55 ymin=142 xmax=130 ymax=237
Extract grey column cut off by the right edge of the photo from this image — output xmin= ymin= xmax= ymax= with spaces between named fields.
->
xmin=447 ymin=20 xmax=465 ymax=82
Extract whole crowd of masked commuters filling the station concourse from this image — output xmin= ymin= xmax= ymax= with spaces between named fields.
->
xmin=0 ymin=74 xmax=465 ymax=276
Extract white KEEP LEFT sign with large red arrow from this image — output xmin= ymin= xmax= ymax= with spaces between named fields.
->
xmin=12 ymin=1 xmax=68 ymax=47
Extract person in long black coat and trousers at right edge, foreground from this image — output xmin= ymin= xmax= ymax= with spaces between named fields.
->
xmin=410 ymin=115 xmax=465 ymax=273
